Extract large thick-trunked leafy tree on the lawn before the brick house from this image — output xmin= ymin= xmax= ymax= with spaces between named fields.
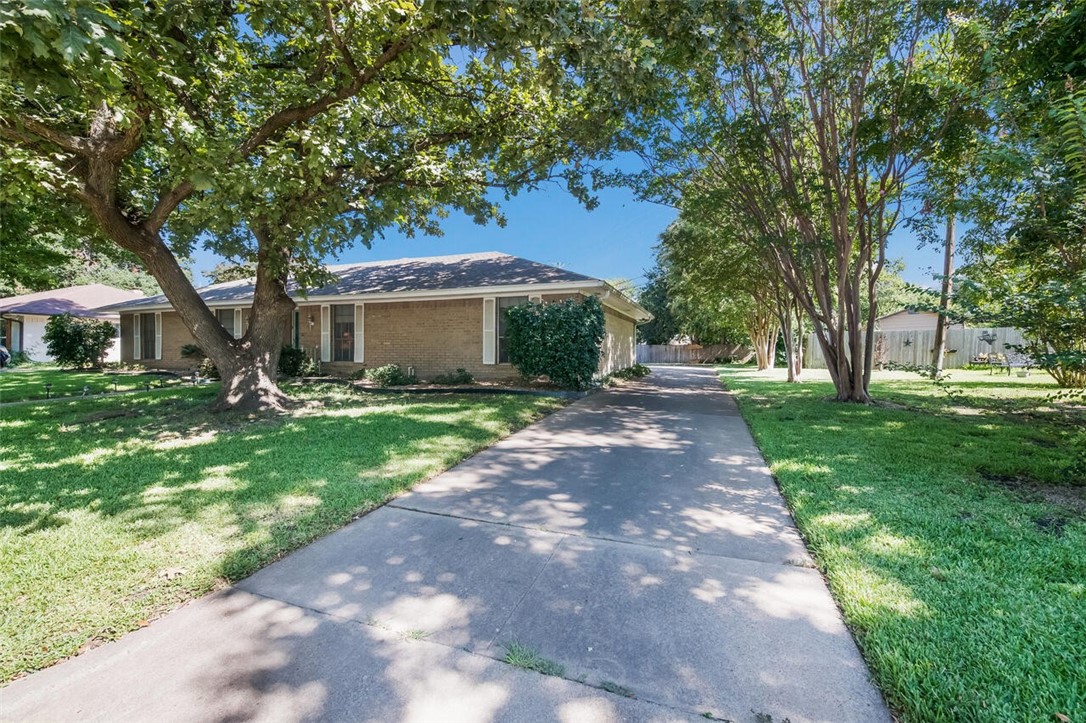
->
xmin=0 ymin=0 xmax=647 ymax=409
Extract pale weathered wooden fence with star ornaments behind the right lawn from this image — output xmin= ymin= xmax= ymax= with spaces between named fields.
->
xmin=804 ymin=326 xmax=1025 ymax=369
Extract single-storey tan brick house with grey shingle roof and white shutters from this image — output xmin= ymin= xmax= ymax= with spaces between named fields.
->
xmin=102 ymin=252 xmax=652 ymax=380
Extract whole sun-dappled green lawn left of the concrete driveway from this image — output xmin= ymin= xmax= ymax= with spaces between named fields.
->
xmin=0 ymin=385 xmax=560 ymax=681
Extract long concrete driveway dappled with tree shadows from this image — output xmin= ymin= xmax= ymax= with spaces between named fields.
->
xmin=0 ymin=367 xmax=889 ymax=723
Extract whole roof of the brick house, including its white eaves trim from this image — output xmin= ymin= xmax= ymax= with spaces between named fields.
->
xmin=102 ymin=252 xmax=651 ymax=320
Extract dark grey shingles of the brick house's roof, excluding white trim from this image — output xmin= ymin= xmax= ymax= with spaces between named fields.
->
xmin=97 ymin=252 xmax=602 ymax=310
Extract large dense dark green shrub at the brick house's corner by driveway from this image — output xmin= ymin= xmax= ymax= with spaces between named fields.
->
xmin=505 ymin=296 xmax=604 ymax=390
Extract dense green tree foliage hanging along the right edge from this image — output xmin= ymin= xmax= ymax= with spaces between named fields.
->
xmin=962 ymin=1 xmax=1086 ymax=388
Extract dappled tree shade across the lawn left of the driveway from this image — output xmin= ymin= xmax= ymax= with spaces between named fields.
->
xmin=0 ymin=390 xmax=551 ymax=579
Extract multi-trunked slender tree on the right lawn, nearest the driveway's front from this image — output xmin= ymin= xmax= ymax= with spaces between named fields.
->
xmin=630 ymin=0 xmax=973 ymax=403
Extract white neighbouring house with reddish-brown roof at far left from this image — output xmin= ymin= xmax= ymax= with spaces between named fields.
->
xmin=0 ymin=283 xmax=143 ymax=362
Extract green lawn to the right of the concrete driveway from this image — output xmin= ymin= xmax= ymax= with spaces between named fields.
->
xmin=721 ymin=367 xmax=1086 ymax=721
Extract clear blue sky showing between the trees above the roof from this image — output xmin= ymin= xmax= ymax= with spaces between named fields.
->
xmin=193 ymin=176 xmax=943 ymax=286
